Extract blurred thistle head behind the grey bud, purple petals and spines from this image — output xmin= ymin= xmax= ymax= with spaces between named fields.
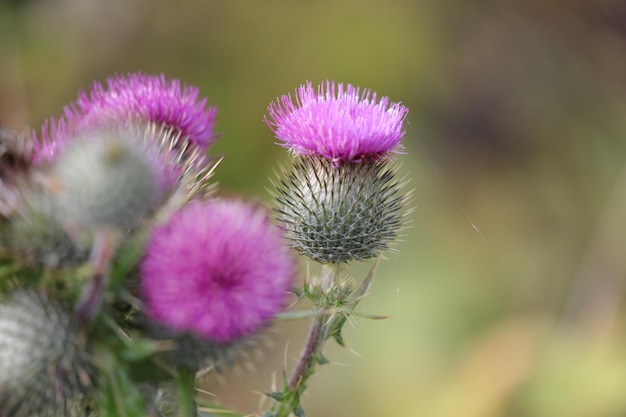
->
xmin=33 ymin=73 xmax=218 ymax=199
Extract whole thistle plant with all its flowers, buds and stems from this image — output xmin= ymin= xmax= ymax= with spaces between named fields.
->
xmin=0 ymin=73 xmax=408 ymax=417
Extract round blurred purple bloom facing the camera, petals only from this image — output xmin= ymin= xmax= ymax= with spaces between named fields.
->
xmin=140 ymin=200 xmax=295 ymax=343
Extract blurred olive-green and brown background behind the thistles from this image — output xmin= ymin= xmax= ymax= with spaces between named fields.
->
xmin=0 ymin=0 xmax=626 ymax=417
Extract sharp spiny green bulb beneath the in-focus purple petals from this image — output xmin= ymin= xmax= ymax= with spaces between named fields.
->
xmin=276 ymin=156 xmax=405 ymax=263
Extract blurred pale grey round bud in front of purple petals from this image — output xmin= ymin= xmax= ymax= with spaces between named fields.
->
xmin=50 ymin=130 xmax=165 ymax=231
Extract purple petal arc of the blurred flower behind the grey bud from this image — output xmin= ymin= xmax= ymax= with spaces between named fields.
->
xmin=33 ymin=73 xmax=217 ymax=163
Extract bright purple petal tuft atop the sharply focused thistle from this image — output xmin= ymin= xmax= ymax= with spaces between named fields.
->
xmin=265 ymin=81 xmax=408 ymax=165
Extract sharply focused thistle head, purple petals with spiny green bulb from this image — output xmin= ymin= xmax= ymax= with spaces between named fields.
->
xmin=266 ymin=82 xmax=408 ymax=263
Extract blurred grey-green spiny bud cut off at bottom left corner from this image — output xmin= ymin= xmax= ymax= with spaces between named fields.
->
xmin=0 ymin=291 xmax=93 ymax=417
